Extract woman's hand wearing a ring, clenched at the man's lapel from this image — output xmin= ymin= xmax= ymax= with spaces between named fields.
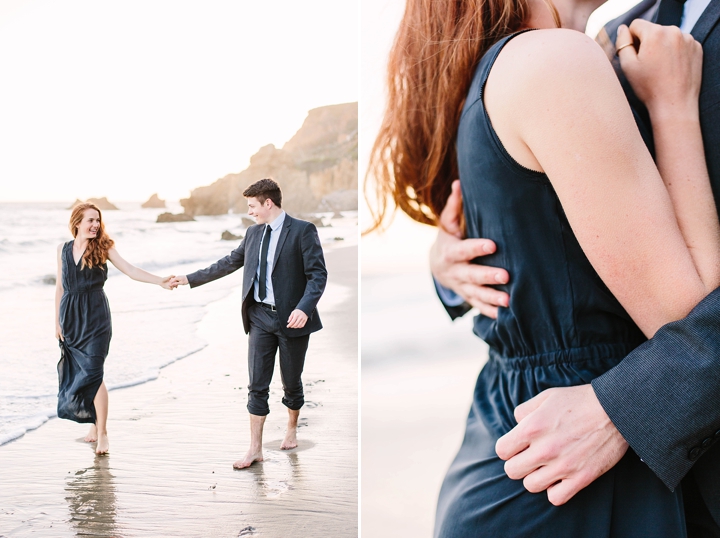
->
xmin=615 ymin=19 xmax=703 ymax=115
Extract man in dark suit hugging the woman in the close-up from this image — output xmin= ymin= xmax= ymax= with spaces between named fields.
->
xmin=431 ymin=0 xmax=720 ymax=536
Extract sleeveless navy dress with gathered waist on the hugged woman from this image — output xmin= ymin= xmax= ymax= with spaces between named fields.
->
xmin=435 ymin=34 xmax=685 ymax=538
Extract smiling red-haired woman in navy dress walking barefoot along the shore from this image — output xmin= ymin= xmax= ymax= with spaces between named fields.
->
xmin=55 ymin=203 xmax=172 ymax=454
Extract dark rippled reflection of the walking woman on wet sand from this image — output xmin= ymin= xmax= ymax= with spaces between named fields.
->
xmin=65 ymin=456 xmax=119 ymax=537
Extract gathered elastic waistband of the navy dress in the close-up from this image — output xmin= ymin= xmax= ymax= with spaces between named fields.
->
xmin=490 ymin=341 xmax=642 ymax=369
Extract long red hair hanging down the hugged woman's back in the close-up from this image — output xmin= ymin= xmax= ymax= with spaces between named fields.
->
xmin=372 ymin=0 xmax=544 ymax=230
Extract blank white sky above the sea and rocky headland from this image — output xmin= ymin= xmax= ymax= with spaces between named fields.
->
xmin=0 ymin=0 xmax=359 ymax=201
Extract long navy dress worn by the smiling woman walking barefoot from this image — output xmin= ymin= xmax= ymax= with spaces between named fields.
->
xmin=58 ymin=241 xmax=112 ymax=423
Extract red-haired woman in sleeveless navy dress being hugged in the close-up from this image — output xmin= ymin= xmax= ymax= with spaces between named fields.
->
xmin=371 ymin=0 xmax=720 ymax=538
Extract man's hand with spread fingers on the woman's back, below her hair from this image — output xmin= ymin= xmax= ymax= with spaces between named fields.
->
xmin=430 ymin=180 xmax=510 ymax=318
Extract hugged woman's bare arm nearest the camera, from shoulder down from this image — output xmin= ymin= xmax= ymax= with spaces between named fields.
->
xmin=485 ymin=30 xmax=720 ymax=336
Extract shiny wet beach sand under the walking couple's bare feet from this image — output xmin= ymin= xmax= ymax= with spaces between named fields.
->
xmin=0 ymin=246 xmax=358 ymax=538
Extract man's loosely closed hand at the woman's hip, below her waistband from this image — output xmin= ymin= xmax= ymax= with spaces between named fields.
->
xmin=495 ymin=385 xmax=628 ymax=506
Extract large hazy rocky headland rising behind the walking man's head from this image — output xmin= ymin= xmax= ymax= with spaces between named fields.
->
xmin=180 ymin=103 xmax=358 ymax=215
